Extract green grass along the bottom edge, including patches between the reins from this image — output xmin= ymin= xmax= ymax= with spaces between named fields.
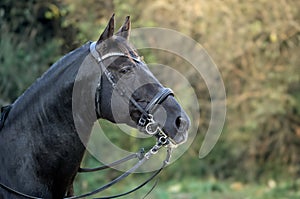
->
xmin=73 ymin=177 xmax=300 ymax=199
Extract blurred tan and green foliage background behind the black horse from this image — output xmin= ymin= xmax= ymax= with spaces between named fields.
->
xmin=0 ymin=0 xmax=300 ymax=199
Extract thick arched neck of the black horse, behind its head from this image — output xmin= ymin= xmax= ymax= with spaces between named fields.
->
xmin=0 ymin=42 xmax=97 ymax=197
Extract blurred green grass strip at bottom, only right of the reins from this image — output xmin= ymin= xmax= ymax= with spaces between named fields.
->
xmin=152 ymin=178 xmax=300 ymax=199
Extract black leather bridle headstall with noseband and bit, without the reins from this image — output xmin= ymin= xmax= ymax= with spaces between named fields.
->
xmin=90 ymin=42 xmax=176 ymax=144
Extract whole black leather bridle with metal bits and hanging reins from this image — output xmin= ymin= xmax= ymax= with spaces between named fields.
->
xmin=0 ymin=42 xmax=176 ymax=199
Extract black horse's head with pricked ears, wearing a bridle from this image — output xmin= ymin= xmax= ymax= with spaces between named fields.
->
xmin=91 ymin=15 xmax=190 ymax=145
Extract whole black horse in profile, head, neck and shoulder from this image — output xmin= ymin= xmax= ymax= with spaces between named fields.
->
xmin=0 ymin=16 xmax=189 ymax=199
